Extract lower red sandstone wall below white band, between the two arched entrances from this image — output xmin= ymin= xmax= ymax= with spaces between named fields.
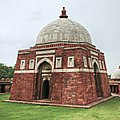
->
xmin=51 ymin=72 xmax=97 ymax=104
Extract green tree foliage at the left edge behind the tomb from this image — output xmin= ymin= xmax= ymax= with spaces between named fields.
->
xmin=0 ymin=63 xmax=14 ymax=79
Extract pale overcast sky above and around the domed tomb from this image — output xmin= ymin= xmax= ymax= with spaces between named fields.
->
xmin=0 ymin=0 xmax=120 ymax=74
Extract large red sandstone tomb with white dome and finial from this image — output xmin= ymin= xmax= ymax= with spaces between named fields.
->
xmin=10 ymin=7 xmax=110 ymax=105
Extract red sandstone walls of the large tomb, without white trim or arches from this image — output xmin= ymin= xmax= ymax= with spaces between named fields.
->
xmin=10 ymin=45 xmax=110 ymax=105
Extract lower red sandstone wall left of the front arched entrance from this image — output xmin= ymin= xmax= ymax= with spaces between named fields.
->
xmin=10 ymin=73 xmax=34 ymax=101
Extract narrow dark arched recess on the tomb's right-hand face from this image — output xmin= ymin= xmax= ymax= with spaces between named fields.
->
xmin=93 ymin=63 xmax=103 ymax=97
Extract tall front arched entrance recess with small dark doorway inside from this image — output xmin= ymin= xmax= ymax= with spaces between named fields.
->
xmin=35 ymin=62 xmax=52 ymax=100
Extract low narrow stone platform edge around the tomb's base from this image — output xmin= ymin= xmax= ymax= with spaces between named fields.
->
xmin=4 ymin=96 xmax=115 ymax=108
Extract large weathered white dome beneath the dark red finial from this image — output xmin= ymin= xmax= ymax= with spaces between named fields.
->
xmin=36 ymin=18 xmax=92 ymax=44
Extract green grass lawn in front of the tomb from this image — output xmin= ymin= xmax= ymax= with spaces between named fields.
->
xmin=0 ymin=94 xmax=120 ymax=120
